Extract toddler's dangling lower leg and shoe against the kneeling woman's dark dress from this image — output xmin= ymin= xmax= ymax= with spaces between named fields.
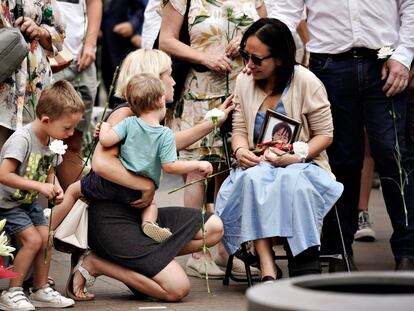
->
xmin=141 ymin=201 xmax=172 ymax=243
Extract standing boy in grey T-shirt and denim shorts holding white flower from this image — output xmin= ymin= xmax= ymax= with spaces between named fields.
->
xmin=0 ymin=81 xmax=84 ymax=310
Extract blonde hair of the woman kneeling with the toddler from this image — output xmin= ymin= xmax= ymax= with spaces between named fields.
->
xmin=115 ymin=49 xmax=171 ymax=99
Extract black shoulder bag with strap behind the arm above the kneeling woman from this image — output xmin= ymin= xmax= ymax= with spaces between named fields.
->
xmin=153 ymin=0 xmax=208 ymax=103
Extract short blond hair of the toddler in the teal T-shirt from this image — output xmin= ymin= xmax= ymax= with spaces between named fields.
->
xmin=126 ymin=73 xmax=165 ymax=116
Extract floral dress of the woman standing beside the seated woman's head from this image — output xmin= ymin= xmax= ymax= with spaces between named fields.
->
xmin=163 ymin=0 xmax=264 ymax=158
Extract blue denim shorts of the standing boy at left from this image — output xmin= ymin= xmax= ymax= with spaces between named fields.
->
xmin=0 ymin=202 xmax=48 ymax=235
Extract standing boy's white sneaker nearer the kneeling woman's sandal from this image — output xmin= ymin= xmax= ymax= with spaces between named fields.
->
xmin=29 ymin=284 xmax=75 ymax=308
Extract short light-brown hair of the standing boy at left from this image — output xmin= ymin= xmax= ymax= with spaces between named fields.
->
xmin=36 ymin=80 xmax=85 ymax=120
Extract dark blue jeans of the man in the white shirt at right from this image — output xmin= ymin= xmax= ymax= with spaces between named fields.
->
xmin=310 ymin=54 xmax=414 ymax=259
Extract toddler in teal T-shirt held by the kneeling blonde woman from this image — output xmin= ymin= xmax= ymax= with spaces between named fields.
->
xmin=59 ymin=74 xmax=213 ymax=243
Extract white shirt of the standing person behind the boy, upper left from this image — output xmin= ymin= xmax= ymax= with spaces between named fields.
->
xmin=57 ymin=0 xmax=88 ymax=57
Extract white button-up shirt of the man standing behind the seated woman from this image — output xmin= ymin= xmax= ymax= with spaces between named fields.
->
xmin=269 ymin=0 xmax=414 ymax=68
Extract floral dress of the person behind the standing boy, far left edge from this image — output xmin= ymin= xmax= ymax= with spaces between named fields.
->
xmin=0 ymin=0 xmax=65 ymax=130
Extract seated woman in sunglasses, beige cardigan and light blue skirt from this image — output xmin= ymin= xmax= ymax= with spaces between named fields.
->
xmin=216 ymin=18 xmax=343 ymax=281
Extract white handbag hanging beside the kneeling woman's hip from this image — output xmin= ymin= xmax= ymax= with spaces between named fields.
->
xmin=53 ymin=199 xmax=88 ymax=253
